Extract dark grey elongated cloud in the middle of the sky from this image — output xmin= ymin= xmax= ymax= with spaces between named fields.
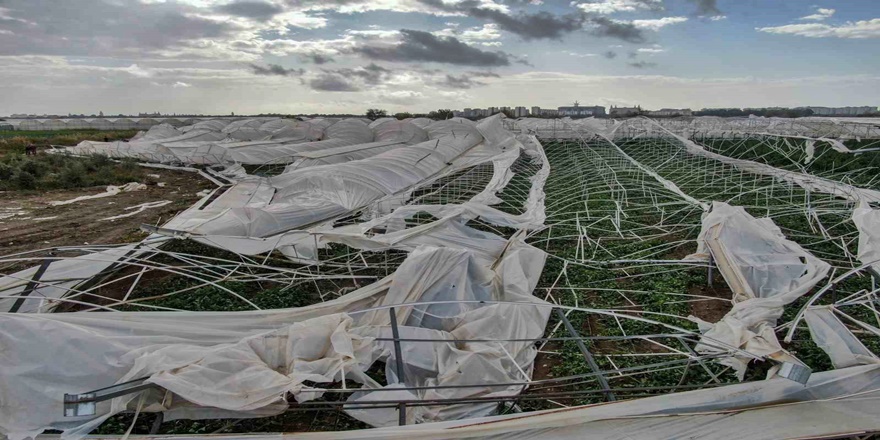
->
xmin=353 ymin=29 xmax=510 ymax=67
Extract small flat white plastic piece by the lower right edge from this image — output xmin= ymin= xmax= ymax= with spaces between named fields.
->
xmin=804 ymin=306 xmax=880 ymax=368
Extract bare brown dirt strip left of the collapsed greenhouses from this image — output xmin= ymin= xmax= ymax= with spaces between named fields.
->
xmin=0 ymin=169 xmax=215 ymax=255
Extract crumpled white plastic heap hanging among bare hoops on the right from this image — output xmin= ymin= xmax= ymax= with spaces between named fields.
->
xmin=689 ymin=202 xmax=830 ymax=380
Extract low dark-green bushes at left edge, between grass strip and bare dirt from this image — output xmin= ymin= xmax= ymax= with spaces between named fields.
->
xmin=0 ymin=154 xmax=144 ymax=191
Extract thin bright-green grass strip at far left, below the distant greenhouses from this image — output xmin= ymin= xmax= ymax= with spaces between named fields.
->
xmin=0 ymin=129 xmax=137 ymax=156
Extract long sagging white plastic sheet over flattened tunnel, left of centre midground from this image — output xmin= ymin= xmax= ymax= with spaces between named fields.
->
xmin=179 ymin=118 xmax=500 ymax=237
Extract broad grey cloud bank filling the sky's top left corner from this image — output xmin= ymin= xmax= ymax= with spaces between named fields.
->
xmin=0 ymin=0 xmax=236 ymax=57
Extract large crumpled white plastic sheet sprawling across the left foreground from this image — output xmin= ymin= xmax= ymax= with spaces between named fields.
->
xmin=0 ymin=243 xmax=549 ymax=438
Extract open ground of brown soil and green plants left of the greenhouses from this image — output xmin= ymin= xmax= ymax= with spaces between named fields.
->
xmin=0 ymin=130 xmax=214 ymax=276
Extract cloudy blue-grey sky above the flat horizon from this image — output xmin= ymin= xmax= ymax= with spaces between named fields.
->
xmin=0 ymin=0 xmax=880 ymax=115
